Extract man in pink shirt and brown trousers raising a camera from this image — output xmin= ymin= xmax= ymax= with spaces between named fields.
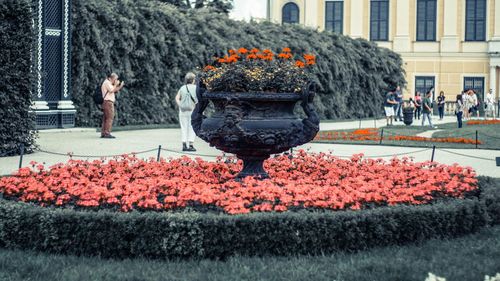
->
xmin=101 ymin=73 xmax=125 ymax=139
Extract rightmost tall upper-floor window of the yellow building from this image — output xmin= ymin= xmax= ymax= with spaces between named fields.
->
xmin=465 ymin=0 xmax=486 ymax=41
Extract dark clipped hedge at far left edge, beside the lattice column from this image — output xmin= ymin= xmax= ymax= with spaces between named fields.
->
xmin=0 ymin=0 xmax=35 ymax=156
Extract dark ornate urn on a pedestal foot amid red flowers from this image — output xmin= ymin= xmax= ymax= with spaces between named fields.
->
xmin=192 ymin=83 xmax=319 ymax=179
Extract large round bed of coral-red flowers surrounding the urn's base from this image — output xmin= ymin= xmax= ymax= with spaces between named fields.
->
xmin=0 ymin=151 xmax=478 ymax=214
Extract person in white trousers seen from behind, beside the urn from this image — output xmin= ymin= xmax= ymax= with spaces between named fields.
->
xmin=175 ymin=72 xmax=198 ymax=151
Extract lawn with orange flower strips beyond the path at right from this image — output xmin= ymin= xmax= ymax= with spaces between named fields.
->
xmin=314 ymin=123 xmax=500 ymax=150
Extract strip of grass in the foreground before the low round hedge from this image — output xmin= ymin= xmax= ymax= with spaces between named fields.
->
xmin=0 ymin=222 xmax=500 ymax=281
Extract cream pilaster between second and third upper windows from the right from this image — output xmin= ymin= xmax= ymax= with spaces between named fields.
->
xmin=393 ymin=0 xmax=411 ymax=53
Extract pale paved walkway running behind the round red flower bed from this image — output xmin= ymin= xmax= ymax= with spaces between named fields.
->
xmin=0 ymin=118 xmax=500 ymax=177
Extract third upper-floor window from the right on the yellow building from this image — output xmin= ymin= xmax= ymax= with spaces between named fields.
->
xmin=370 ymin=0 xmax=389 ymax=41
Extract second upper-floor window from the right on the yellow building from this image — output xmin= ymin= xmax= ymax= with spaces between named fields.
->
xmin=417 ymin=0 xmax=436 ymax=41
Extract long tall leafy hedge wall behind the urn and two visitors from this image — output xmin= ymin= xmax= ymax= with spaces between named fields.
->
xmin=72 ymin=0 xmax=405 ymax=126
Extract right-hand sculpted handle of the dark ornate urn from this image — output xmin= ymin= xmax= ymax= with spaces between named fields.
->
xmin=301 ymin=83 xmax=319 ymax=142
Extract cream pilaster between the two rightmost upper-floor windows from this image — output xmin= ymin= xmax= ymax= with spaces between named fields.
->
xmin=441 ymin=0 xmax=459 ymax=53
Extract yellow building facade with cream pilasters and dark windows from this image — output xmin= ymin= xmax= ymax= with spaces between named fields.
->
xmin=268 ymin=0 xmax=500 ymax=104
